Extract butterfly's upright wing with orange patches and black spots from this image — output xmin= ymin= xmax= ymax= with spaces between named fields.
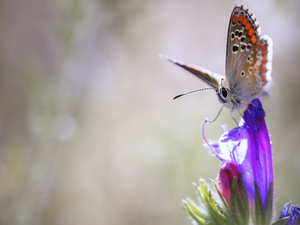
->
xmin=226 ymin=6 xmax=273 ymax=102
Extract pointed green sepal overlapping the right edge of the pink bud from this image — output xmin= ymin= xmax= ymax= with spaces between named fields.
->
xmin=230 ymin=177 xmax=248 ymax=224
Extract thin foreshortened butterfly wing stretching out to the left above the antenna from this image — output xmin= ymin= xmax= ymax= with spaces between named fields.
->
xmin=159 ymin=55 xmax=223 ymax=90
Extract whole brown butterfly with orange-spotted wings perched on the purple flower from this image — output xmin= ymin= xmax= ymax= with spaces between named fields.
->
xmin=160 ymin=5 xmax=273 ymax=122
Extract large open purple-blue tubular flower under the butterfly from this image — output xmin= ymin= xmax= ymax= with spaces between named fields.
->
xmin=203 ymin=99 xmax=274 ymax=212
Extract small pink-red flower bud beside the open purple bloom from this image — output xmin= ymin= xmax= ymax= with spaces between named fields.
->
xmin=217 ymin=162 xmax=241 ymax=206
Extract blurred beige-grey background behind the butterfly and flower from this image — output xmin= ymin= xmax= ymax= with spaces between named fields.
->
xmin=0 ymin=0 xmax=300 ymax=225
